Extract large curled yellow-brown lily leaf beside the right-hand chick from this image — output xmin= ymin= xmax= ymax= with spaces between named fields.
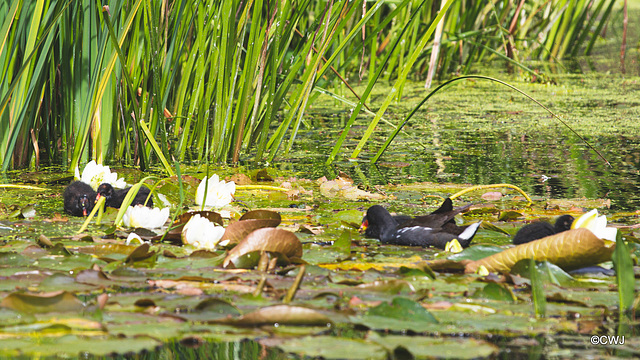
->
xmin=465 ymin=229 xmax=615 ymax=273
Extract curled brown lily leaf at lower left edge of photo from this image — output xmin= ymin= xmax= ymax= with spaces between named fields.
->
xmin=0 ymin=291 xmax=84 ymax=314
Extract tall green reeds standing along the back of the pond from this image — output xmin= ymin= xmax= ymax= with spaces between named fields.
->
xmin=0 ymin=0 xmax=614 ymax=172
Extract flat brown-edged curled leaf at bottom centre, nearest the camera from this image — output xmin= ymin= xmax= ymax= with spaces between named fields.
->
xmin=218 ymin=305 xmax=331 ymax=326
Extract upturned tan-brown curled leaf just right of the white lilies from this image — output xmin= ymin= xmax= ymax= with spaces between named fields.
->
xmin=223 ymin=229 xmax=302 ymax=268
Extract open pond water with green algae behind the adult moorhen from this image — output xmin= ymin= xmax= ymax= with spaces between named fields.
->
xmin=276 ymin=70 xmax=640 ymax=211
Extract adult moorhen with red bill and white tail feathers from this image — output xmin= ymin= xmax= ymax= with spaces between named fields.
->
xmin=365 ymin=199 xmax=480 ymax=249
